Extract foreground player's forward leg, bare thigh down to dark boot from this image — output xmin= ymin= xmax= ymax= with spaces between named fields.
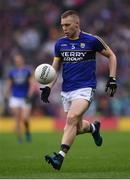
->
xmin=45 ymin=99 xmax=89 ymax=170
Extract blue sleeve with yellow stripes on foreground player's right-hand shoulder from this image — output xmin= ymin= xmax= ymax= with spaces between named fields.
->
xmin=94 ymin=36 xmax=108 ymax=52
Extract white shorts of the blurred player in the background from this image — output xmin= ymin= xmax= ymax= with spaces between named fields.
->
xmin=9 ymin=96 xmax=31 ymax=109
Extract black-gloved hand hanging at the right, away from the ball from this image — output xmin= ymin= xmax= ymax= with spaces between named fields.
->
xmin=105 ymin=77 xmax=117 ymax=97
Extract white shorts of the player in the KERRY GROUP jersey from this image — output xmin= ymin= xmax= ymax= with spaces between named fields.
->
xmin=61 ymin=88 xmax=95 ymax=112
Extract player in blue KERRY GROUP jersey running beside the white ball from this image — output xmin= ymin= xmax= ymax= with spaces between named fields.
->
xmin=41 ymin=10 xmax=117 ymax=170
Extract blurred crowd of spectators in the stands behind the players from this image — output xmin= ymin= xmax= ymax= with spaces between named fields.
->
xmin=0 ymin=0 xmax=130 ymax=116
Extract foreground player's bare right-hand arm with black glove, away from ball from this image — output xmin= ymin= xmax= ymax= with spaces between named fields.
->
xmin=100 ymin=46 xmax=117 ymax=97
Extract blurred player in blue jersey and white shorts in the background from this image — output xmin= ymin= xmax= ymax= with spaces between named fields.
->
xmin=6 ymin=54 xmax=33 ymax=143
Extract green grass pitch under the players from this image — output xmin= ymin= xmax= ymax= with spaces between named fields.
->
xmin=0 ymin=132 xmax=130 ymax=179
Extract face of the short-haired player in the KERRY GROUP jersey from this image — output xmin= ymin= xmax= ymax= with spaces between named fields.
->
xmin=61 ymin=16 xmax=79 ymax=38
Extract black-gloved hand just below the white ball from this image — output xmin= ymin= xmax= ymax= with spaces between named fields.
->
xmin=40 ymin=86 xmax=51 ymax=103
